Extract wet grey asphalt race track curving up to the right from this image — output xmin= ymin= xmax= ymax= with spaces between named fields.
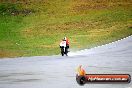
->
xmin=0 ymin=36 xmax=132 ymax=88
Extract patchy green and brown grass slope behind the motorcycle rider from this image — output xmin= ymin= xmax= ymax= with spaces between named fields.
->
xmin=0 ymin=0 xmax=132 ymax=57
